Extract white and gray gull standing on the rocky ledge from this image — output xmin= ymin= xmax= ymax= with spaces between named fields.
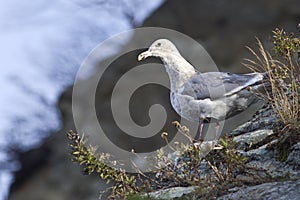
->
xmin=138 ymin=39 xmax=267 ymax=141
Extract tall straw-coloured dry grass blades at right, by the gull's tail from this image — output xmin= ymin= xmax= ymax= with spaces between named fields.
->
xmin=244 ymin=33 xmax=300 ymax=130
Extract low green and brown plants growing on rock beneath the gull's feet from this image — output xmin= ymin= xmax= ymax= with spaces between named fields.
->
xmin=68 ymin=123 xmax=264 ymax=199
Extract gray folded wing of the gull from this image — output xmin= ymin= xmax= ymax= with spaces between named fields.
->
xmin=181 ymin=72 xmax=264 ymax=100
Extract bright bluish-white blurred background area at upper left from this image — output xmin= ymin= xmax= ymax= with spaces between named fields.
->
xmin=0 ymin=0 xmax=162 ymax=200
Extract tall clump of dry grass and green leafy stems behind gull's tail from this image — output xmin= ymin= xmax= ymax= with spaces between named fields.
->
xmin=244 ymin=29 xmax=300 ymax=158
